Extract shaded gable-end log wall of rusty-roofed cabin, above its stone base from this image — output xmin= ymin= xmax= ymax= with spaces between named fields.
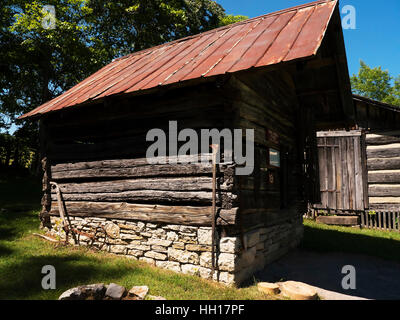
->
xmin=229 ymin=71 xmax=302 ymax=229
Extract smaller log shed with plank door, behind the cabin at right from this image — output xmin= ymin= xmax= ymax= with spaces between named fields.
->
xmin=313 ymin=95 xmax=400 ymax=229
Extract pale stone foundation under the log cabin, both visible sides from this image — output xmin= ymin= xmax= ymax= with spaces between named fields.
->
xmin=50 ymin=217 xmax=303 ymax=284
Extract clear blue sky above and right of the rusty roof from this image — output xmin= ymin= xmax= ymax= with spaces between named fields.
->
xmin=217 ymin=0 xmax=400 ymax=76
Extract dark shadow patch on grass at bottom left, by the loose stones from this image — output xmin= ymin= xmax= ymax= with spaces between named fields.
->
xmin=0 ymin=252 xmax=140 ymax=300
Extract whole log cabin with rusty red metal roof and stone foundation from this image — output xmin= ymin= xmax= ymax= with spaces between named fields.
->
xmin=22 ymin=1 xmax=353 ymax=284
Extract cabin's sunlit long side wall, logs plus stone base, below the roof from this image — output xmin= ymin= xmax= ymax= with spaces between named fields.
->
xmin=42 ymin=83 xmax=250 ymax=283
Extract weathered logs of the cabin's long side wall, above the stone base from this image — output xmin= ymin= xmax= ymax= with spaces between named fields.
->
xmin=43 ymin=83 xmax=239 ymax=225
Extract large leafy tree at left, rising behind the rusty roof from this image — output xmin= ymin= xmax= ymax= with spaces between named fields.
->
xmin=0 ymin=0 xmax=244 ymax=172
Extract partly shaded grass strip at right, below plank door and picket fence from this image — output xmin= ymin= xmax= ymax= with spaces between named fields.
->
xmin=302 ymin=220 xmax=400 ymax=262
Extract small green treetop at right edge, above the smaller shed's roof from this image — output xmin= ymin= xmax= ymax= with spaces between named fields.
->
xmin=351 ymin=61 xmax=400 ymax=107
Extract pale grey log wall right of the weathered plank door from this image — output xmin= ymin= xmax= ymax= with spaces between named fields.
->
xmin=366 ymin=131 xmax=400 ymax=211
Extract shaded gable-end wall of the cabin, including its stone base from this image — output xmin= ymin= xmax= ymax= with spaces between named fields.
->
xmin=222 ymin=72 xmax=305 ymax=278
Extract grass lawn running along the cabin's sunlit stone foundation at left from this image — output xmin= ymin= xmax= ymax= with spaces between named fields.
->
xmin=0 ymin=179 xmax=271 ymax=300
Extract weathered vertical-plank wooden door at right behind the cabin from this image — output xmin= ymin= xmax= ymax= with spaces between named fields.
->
xmin=314 ymin=130 xmax=368 ymax=211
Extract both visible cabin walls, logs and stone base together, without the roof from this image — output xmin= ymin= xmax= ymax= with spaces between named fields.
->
xmin=43 ymin=73 xmax=307 ymax=284
